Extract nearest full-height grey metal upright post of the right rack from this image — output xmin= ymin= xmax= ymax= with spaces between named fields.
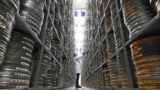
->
xmin=114 ymin=0 xmax=137 ymax=88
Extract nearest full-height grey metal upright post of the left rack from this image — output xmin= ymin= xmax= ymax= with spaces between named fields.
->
xmin=32 ymin=0 xmax=51 ymax=90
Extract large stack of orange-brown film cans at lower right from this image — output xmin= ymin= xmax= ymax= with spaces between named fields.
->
xmin=130 ymin=36 xmax=160 ymax=89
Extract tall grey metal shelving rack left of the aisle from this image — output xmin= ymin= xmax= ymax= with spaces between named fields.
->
xmin=0 ymin=0 xmax=74 ymax=90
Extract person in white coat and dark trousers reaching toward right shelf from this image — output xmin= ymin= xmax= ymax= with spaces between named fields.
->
xmin=74 ymin=51 xmax=88 ymax=88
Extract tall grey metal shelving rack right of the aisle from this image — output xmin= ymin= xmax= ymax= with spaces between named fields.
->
xmin=82 ymin=0 xmax=160 ymax=90
